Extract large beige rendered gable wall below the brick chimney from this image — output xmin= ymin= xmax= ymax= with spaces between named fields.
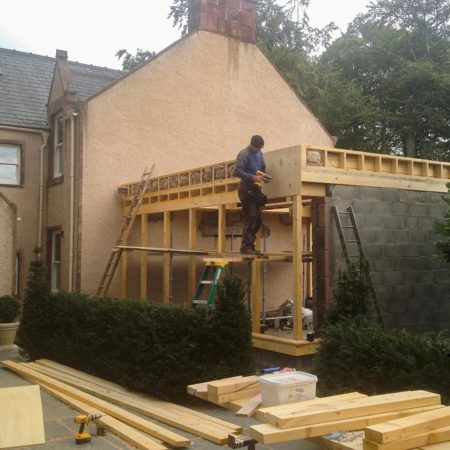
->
xmin=81 ymin=32 xmax=333 ymax=293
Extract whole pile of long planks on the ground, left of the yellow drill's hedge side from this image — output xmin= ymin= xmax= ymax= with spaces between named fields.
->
xmin=2 ymin=360 xmax=242 ymax=450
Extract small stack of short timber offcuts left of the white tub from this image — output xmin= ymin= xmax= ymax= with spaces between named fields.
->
xmin=187 ymin=375 xmax=261 ymax=417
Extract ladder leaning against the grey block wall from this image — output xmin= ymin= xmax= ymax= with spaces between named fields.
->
xmin=331 ymin=206 xmax=384 ymax=325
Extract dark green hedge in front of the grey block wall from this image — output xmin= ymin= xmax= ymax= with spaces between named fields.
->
xmin=315 ymin=318 xmax=450 ymax=402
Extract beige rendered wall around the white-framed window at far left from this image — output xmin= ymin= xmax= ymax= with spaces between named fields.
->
xmin=0 ymin=129 xmax=42 ymax=294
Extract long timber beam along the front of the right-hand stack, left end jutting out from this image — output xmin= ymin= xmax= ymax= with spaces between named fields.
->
xmin=249 ymin=405 xmax=442 ymax=444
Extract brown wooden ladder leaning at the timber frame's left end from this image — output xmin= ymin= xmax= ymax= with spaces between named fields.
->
xmin=97 ymin=164 xmax=155 ymax=297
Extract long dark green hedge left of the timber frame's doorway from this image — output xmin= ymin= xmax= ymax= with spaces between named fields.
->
xmin=18 ymin=260 xmax=254 ymax=399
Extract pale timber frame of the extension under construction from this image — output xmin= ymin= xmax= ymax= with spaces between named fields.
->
xmin=119 ymin=145 xmax=450 ymax=356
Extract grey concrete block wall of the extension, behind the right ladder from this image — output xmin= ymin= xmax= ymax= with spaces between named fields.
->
xmin=330 ymin=186 xmax=450 ymax=331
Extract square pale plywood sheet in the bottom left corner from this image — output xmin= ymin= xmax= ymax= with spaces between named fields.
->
xmin=0 ymin=386 xmax=45 ymax=448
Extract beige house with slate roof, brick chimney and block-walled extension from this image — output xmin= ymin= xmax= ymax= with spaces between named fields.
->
xmin=0 ymin=0 xmax=450 ymax=348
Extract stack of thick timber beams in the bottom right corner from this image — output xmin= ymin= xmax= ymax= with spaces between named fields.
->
xmin=250 ymin=391 xmax=450 ymax=450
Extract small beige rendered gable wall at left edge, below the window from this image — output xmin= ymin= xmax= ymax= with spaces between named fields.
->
xmin=0 ymin=193 xmax=16 ymax=296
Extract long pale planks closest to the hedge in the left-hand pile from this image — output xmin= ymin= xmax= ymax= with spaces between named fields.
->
xmin=28 ymin=360 xmax=242 ymax=444
